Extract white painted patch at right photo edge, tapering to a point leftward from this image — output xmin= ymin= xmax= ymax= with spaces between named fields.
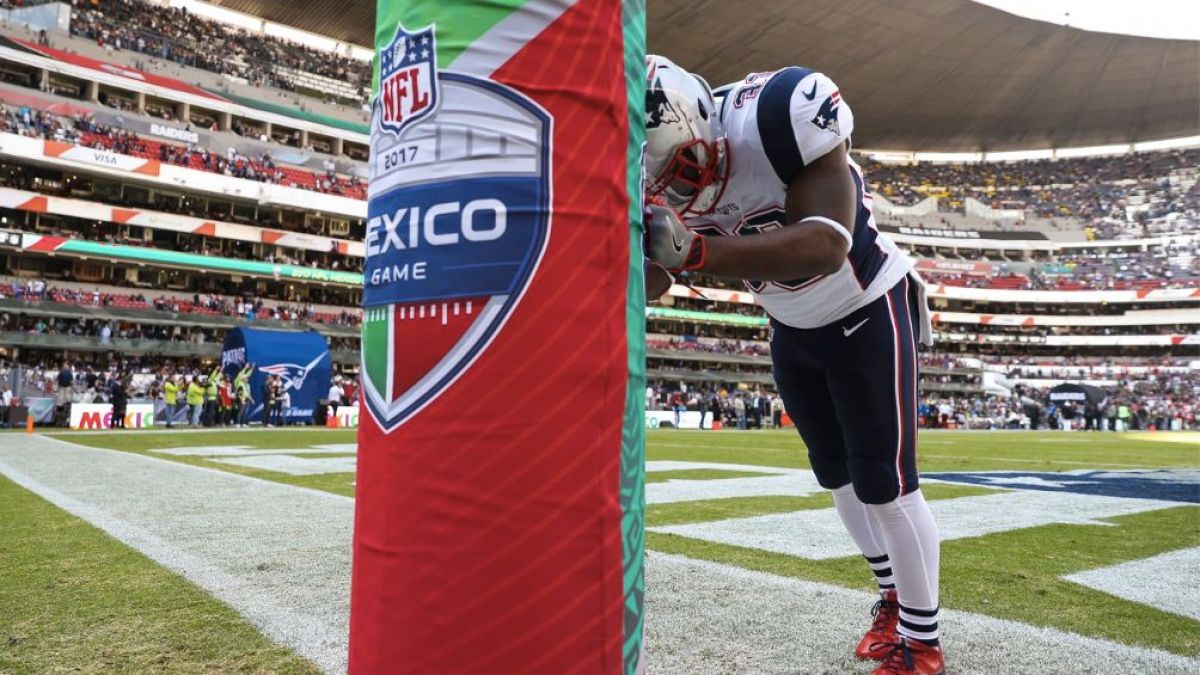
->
xmin=1063 ymin=548 xmax=1200 ymax=621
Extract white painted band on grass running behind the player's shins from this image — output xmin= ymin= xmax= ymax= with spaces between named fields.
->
xmin=647 ymin=487 xmax=1183 ymax=560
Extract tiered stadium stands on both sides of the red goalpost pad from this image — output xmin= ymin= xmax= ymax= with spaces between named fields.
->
xmin=0 ymin=0 xmax=1200 ymax=428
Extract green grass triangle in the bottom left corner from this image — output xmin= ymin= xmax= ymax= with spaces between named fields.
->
xmin=0 ymin=477 xmax=318 ymax=674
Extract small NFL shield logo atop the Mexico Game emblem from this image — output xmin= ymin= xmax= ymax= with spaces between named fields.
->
xmin=378 ymin=25 xmax=438 ymax=136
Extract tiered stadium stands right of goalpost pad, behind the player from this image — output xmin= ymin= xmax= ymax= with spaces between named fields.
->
xmin=647 ymin=150 xmax=1200 ymax=429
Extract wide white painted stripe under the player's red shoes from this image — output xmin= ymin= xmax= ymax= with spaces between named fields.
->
xmin=646 ymin=551 xmax=1200 ymax=675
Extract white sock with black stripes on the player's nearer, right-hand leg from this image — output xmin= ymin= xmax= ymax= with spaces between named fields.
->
xmin=866 ymin=490 xmax=940 ymax=644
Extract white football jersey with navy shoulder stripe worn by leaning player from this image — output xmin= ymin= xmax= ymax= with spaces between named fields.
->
xmin=688 ymin=67 xmax=912 ymax=328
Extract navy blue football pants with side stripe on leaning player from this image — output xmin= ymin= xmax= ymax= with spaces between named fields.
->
xmin=770 ymin=271 xmax=920 ymax=504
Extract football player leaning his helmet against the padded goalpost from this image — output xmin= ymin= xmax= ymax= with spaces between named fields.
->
xmin=646 ymin=55 xmax=944 ymax=675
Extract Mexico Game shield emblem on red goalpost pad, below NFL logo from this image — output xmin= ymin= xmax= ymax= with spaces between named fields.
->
xmin=361 ymin=65 xmax=552 ymax=431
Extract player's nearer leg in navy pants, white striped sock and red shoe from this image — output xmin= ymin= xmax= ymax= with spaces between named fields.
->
xmin=827 ymin=279 xmax=941 ymax=673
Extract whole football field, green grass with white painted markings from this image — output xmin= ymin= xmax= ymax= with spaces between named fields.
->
xmin=0 ymin=429 xmax=1200 ymax=673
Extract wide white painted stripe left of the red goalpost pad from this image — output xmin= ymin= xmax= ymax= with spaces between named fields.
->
xmin=0 ymin=436 xmax=354 ymax=673
